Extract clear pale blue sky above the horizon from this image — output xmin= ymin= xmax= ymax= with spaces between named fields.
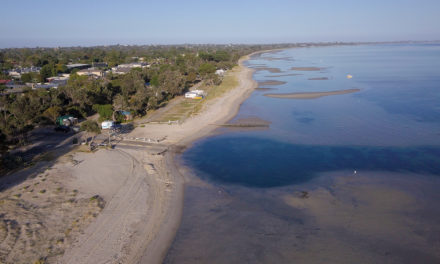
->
xmin=0 ymin=0 xmax=440 ymax=48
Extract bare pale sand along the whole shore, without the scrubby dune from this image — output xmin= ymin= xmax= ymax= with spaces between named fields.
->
xmin=61 ymin=56 xmax=257 ymax=263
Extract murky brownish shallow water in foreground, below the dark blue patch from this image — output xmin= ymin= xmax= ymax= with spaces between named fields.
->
xmin=165 ymin=171 xmax=440 ymax=263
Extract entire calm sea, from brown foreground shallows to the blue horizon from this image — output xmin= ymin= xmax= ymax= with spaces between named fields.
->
xmin=165 ymin=44 xmax=440 ymax=263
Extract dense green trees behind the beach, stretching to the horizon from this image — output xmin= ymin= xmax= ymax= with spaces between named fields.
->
xmin=0 ymin=42 xmax=308 ymax=168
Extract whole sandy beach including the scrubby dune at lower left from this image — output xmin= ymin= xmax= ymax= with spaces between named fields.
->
xmin=0 ymin=52 xmax=258 ymax=264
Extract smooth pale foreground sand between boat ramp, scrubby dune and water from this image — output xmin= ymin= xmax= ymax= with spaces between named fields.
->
xmin=61 ymin=149 xmax=181 ymax=264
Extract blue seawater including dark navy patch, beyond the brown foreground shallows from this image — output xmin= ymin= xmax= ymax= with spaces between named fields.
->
xmin=183 ymin=44 xmax=440 ymax=187
